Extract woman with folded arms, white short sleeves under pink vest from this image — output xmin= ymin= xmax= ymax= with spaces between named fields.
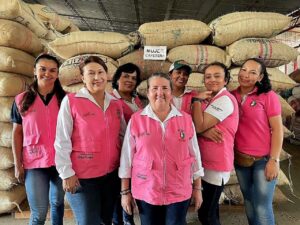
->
xmin=192 ymin=62 xmax=239 ymax=225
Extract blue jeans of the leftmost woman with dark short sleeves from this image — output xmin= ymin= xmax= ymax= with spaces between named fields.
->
xmin=25 ymin=166 xmax=64 ymax=225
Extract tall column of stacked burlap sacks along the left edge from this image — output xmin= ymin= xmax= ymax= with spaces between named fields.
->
xmin=0 ymin=13 xmax=43 ymax=213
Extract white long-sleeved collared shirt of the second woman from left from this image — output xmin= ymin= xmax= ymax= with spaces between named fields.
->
xmin=54 ymin=88 xmax=126 ymax=179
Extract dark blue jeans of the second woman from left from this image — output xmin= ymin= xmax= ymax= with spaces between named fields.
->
xmin=66 ymin=170 xmax=120 ymax=225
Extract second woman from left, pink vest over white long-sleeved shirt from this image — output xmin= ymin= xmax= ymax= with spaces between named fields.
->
xmin=55 ymin=56 xmax=126 ymax=225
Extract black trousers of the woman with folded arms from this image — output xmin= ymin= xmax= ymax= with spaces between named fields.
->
xmin=198 ymin=180 xmax=224 ymax=225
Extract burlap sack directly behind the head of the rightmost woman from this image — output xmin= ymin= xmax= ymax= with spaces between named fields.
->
xmin=228 ymin=68 xmax=296 ymax=92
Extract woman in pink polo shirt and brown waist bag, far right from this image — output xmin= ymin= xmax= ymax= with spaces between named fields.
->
xmin=232 ymin=58 xmax=283 ymax=225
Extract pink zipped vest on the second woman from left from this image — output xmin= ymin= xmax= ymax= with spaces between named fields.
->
xmin=68 ymin=94 xmax=122 ymax=179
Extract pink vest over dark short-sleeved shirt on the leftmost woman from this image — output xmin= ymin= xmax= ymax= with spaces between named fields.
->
xmin=16 ymin=92 xmax=59 ymax=169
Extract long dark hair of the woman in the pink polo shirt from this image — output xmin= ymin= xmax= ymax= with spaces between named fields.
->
xmin=242 ymin=58 xmax=272 ymax=95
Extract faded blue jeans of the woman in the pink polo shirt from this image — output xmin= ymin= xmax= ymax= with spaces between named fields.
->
xmin=235 ymin=158 xmax=276 ymax=225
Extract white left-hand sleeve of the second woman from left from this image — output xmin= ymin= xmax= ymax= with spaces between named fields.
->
xmin=54 ymin=96 xmax=75 ymax=179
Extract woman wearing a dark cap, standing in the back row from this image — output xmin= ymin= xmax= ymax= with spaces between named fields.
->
xmin=169 ymin=60 xmax=197 ymax=114
